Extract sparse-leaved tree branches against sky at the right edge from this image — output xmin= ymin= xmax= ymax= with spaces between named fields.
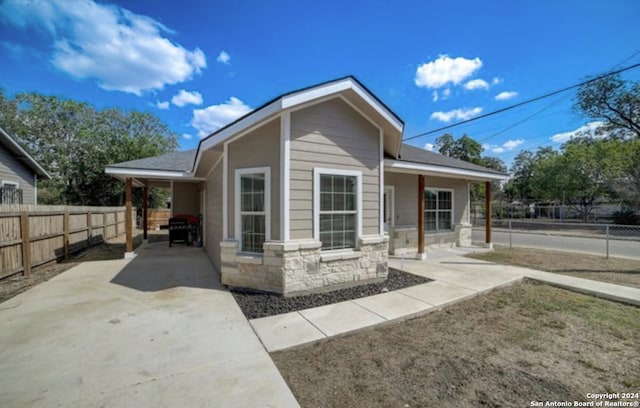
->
xmin=574 ymin=75 xmax=640 ymax=138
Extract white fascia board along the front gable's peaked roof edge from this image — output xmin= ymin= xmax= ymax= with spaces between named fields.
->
xmin=282 ymin=79 xmax=403 ymax=132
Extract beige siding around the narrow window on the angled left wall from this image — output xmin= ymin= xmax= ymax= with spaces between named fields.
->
xmin=228 ymin=119 xmax=280 ymax=240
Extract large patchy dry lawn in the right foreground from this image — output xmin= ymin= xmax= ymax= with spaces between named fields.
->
xmin=272 ymin=283 xmax=640 ymax=407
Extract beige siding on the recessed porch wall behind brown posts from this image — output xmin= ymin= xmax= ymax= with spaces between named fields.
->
xmin=384 ymin=173 xmax=469 ymax=226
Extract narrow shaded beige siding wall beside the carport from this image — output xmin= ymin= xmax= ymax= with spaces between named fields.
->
xmin=204 ymin=161 xmax=222 ymax=271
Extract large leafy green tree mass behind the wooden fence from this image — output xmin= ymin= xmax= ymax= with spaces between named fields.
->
xmin=0 ymin=92 xmax=177 ymax=206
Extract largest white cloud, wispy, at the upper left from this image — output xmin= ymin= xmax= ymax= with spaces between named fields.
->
xmin=0 ymin=0 xmax=207 ymax=95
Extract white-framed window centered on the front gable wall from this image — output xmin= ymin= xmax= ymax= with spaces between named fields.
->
xmin=314 ymin=169 xmax=362 ymax=250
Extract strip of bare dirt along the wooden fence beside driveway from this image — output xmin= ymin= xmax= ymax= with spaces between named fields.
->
xmin=0 ymin=231 xmax=168 ymax=303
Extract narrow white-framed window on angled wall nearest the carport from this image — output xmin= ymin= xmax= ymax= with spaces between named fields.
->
xmin=235 ymin=167 xmax=271 ymax=253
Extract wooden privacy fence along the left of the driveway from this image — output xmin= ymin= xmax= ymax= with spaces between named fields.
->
xmin=0 ymin=205 xmax=135 ymax=279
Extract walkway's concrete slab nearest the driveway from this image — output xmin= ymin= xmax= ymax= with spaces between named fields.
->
xmin=249 ymin=312 xmax=326 ymax=351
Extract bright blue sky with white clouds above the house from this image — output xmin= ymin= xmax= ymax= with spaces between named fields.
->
xmin=0 ymin=0 xmax=640 ymax=167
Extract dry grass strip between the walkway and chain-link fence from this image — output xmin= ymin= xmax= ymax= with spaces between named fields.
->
xmin=468 ymin=247 xmax=640 ymax=288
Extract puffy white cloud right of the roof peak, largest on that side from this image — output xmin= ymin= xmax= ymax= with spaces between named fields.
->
xmin=414 ymin=55 xmax=482 ymax=88
